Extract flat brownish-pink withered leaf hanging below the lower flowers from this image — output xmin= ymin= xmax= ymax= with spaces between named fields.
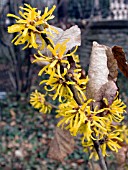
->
xmin=47 ymin=127 xmax=74 ymax=161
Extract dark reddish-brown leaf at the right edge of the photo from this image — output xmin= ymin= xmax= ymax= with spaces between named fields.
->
xmin=112 ymin=46 xmax=128 ymax=78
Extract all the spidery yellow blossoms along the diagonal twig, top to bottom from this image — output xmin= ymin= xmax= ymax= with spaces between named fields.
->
xmin=7 ymin=4 xmax=126 ymax=162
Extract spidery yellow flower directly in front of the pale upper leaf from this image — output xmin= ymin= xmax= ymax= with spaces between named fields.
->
xmin=33 ymin=40 xmax=77 ymax=78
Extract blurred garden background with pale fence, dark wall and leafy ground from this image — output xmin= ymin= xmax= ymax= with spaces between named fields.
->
xmin=0 ymin=0 xmax=128 ymax=170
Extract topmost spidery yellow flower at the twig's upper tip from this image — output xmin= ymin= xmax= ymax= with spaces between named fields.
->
xmin=7 ymin=4 xmax=56 ymax=49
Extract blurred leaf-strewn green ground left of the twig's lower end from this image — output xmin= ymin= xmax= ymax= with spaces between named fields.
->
xmin=0 ymin=95 xmax=88 ymax=170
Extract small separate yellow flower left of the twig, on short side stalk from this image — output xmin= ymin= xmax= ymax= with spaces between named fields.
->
xmin=30 ymin=90 xmax=52 ymax=113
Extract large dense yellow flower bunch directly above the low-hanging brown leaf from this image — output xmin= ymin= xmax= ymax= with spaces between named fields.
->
xmin=56 ymin=98 xmax=107 ymax=138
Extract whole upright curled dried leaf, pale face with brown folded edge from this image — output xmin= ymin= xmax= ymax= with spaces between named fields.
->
xmin=87 ymin=42 xmax=118 ymax=109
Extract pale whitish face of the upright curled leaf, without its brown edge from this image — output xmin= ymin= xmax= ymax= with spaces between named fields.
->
xmin=87 ymin=42 xmax=109 ymax=98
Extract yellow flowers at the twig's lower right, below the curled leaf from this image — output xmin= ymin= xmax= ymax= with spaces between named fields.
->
xmin=82 ymin=94 xmax=126 ymax=159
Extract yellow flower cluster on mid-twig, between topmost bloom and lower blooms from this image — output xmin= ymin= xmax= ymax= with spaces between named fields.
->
xmin=33 ymin=40 xmax=88 ymax=102
